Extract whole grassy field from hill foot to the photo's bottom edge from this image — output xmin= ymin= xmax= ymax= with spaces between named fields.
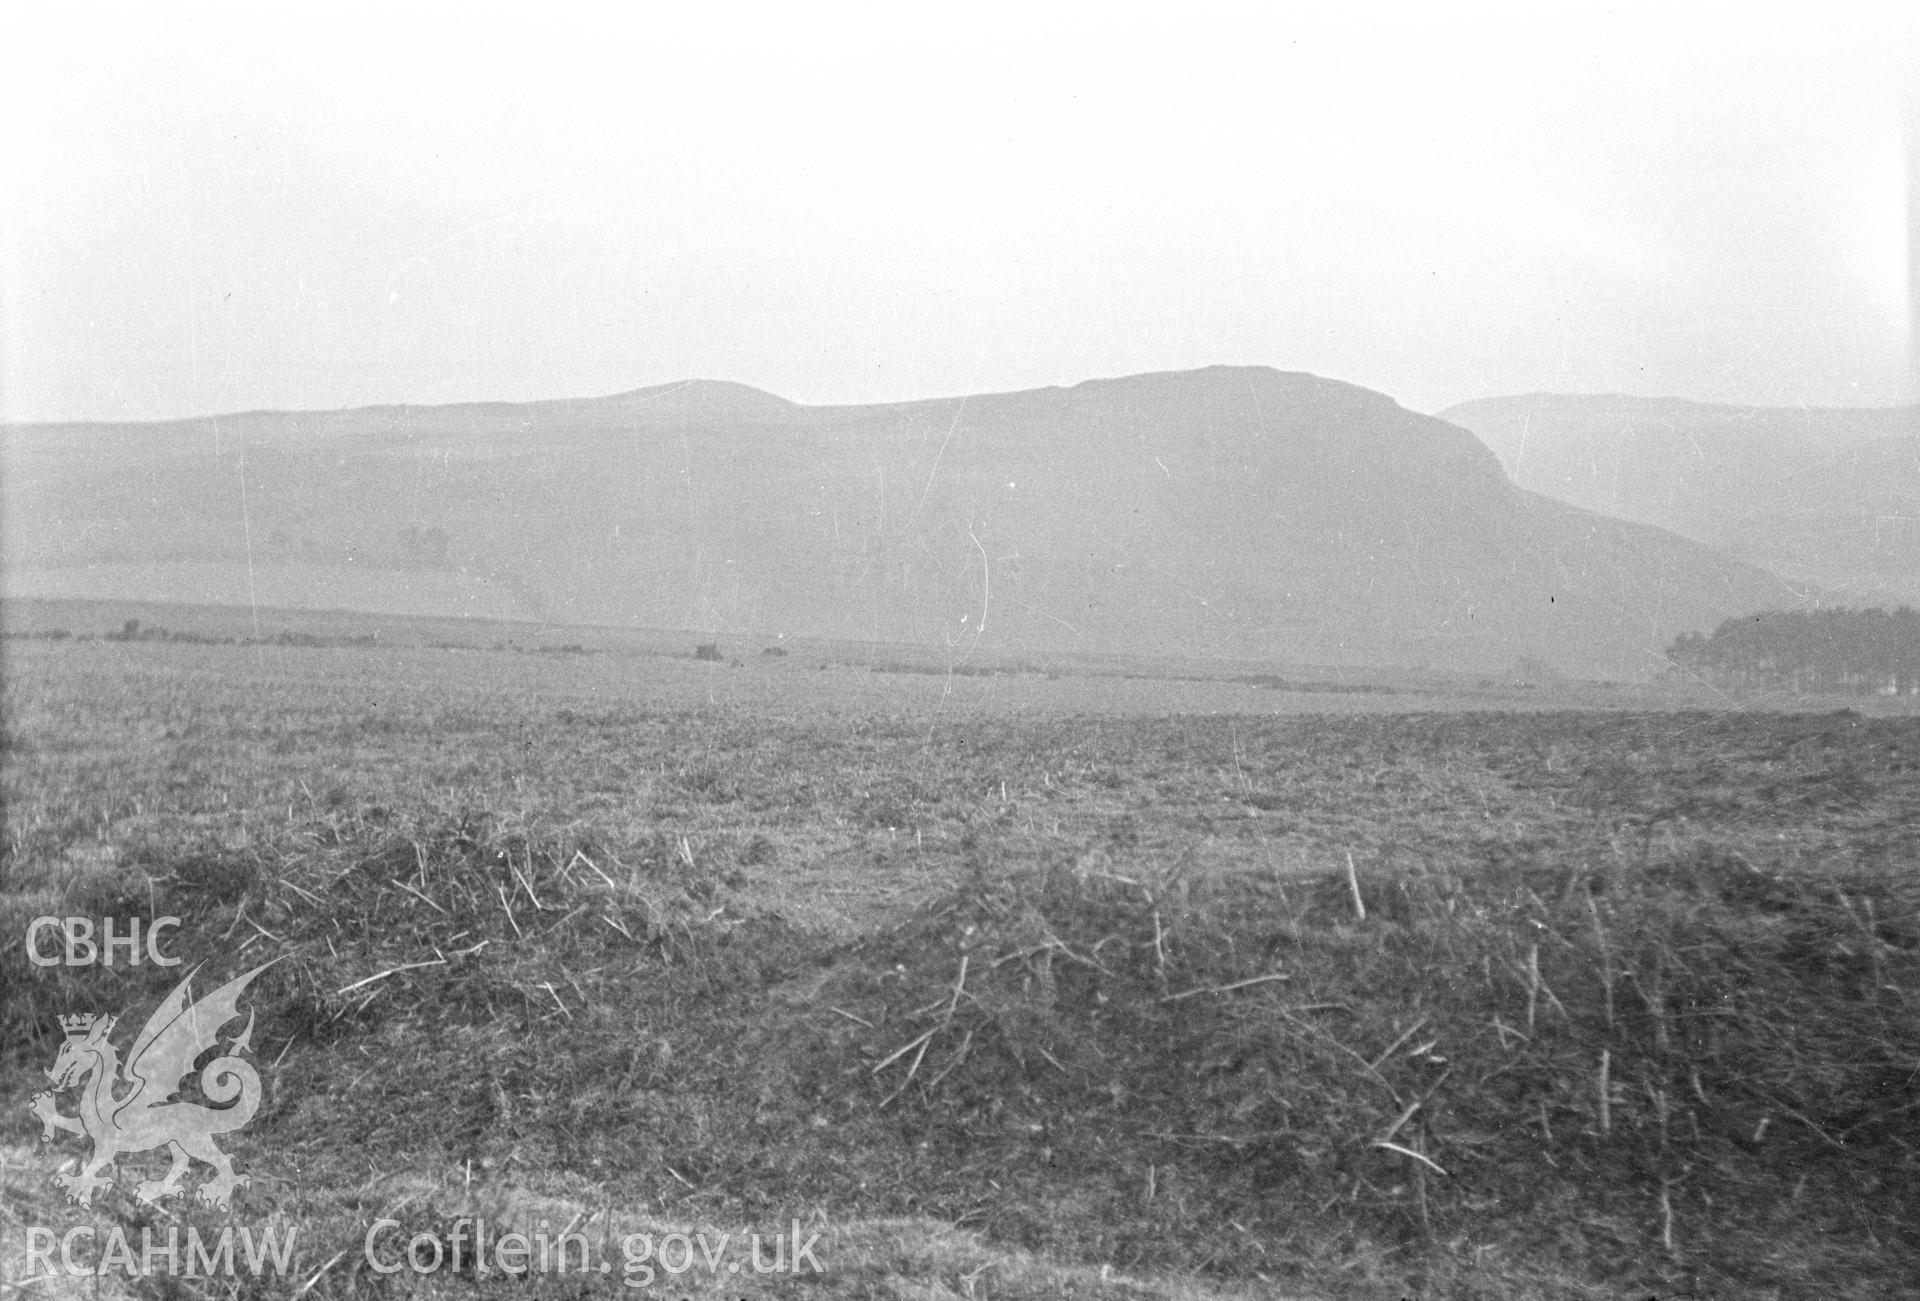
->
xmin=0 ymin=635 xmax=1920 ymax=1299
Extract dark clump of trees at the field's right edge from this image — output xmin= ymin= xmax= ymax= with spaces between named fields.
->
xmin=1667 ymin=606 xmax=1920 ymax=695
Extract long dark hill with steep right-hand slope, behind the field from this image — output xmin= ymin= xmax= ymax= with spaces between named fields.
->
xmin=6 ymin=367 xmax=1797 ymax=675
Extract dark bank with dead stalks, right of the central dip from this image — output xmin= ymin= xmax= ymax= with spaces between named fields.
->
xmin=843 ymin=846 xmax=1920 ymax=1295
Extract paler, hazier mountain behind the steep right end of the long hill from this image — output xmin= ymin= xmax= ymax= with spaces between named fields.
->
xmin=1440 ymin=393 xmax=1920 ymax=604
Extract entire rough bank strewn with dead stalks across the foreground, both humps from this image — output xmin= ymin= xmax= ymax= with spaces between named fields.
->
xmin=15 ymin=816 xmax=1920 ymax=1295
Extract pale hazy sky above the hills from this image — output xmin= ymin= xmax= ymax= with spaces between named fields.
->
xmin=0 ymin=0 xmax=1920 ymax=418
